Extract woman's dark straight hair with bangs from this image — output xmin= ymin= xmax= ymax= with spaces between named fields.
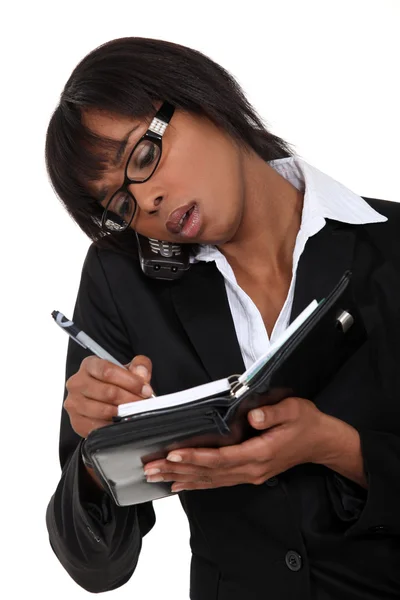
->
xmin=46 ymin=37 xmax=293 ymax=253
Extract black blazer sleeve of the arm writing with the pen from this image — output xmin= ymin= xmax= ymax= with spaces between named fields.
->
xmin=46 ymin=245 xmax=155 ymax=592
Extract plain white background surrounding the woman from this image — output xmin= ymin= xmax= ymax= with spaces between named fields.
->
xmin=0 ymin=0 xmax=400 ymax=600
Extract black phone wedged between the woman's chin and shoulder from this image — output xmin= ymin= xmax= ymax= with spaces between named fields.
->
xmin=136 ymin=233 xmax=190 ymax=281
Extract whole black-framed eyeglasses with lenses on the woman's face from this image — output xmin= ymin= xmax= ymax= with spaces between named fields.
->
xmin=101 ymin=102 xmax=175 ymax=232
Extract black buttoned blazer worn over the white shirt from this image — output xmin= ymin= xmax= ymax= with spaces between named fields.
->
xmin=47 ymin=199 xmax=400 ymax=600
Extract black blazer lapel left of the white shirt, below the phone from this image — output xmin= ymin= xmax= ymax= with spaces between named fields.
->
xmin=171 ymin=262 xmax=245 ymax=380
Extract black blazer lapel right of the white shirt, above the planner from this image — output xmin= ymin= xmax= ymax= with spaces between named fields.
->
xmin=290 ymin=221 xmax=356 ymax=322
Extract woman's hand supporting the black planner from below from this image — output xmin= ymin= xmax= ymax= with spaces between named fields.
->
xmin=144 ymin=398 xmax=348 ymax=492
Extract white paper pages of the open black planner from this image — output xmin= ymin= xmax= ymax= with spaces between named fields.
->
xmin=118 ymin=300 xmax=318 ymax=417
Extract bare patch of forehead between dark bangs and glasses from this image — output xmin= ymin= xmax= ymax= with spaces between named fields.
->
xmin=82 ymin=109 xmax=147 ymax=141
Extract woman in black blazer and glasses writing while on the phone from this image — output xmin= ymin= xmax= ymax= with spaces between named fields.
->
xmin=46 ymin=38 xmax=400 ymax=600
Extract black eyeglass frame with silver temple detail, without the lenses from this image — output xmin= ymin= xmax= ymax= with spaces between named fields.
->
xmin=101 ymin=102 xmax=175 ymax=232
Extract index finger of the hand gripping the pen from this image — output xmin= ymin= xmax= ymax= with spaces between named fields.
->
xmin=82 ymin=356 xmax=151 ymax=397
